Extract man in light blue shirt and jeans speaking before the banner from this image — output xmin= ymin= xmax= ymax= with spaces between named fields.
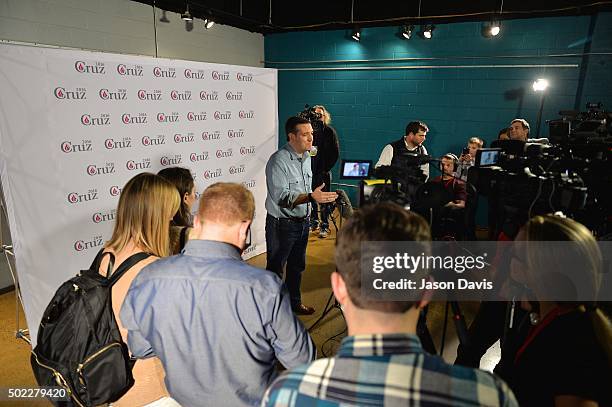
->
xmin=266 ymin=117 xmax=338 ymax=315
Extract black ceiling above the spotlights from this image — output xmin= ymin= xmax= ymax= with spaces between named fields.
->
xmin=134 ymin=0 xmax=612 ymax=34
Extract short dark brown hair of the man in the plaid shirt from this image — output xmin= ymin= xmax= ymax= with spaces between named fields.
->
xmin=335 ymin=202 xmax=431 ymax=313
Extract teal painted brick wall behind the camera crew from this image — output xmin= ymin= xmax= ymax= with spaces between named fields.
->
xmin=265 ymin=13 xmax=612 ymax=209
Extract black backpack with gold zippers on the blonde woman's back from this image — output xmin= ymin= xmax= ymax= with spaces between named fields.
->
xmin=30 ymin=249 xmax=150 ymax=406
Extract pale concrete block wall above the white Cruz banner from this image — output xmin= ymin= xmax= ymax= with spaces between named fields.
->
xmin=0 ymin=0 xmax=264 ymax=66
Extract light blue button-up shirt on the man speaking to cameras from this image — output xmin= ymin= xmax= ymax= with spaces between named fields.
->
xmin=266 ymin=143 xmax=312 ymax=218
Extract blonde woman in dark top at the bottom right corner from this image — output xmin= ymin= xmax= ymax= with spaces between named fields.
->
xmin=507 ymin=215 xmax=612 ymax=407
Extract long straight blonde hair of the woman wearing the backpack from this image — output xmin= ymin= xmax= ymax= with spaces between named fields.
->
xmin=106 ymin=172 xmax=181 ymax=257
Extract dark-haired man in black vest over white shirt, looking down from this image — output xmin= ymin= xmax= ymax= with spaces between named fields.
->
xmin=375 ymin=121 xmax=429 ymax=181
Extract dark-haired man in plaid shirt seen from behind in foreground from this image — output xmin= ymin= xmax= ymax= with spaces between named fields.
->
xmin=262 ymin=203 xmax=518 ymax=407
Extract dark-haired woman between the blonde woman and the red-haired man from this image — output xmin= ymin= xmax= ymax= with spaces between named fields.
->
xmin=157 ymin=167 xmax=196 ymax=254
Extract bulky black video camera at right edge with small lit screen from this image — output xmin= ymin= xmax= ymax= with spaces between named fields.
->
xmin=468 ymin=103 xmax=612 ymax=236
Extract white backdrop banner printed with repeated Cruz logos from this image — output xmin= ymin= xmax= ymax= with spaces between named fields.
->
xmin=0 ymin=44 xmax=278 ymax=344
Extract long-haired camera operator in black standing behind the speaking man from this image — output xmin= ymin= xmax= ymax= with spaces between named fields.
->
xmin=310 ymin=105 xmax=340 ymax=238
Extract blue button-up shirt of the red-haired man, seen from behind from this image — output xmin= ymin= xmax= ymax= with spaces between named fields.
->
xmin=120 ymin=240 xmax=315 ymax=406
